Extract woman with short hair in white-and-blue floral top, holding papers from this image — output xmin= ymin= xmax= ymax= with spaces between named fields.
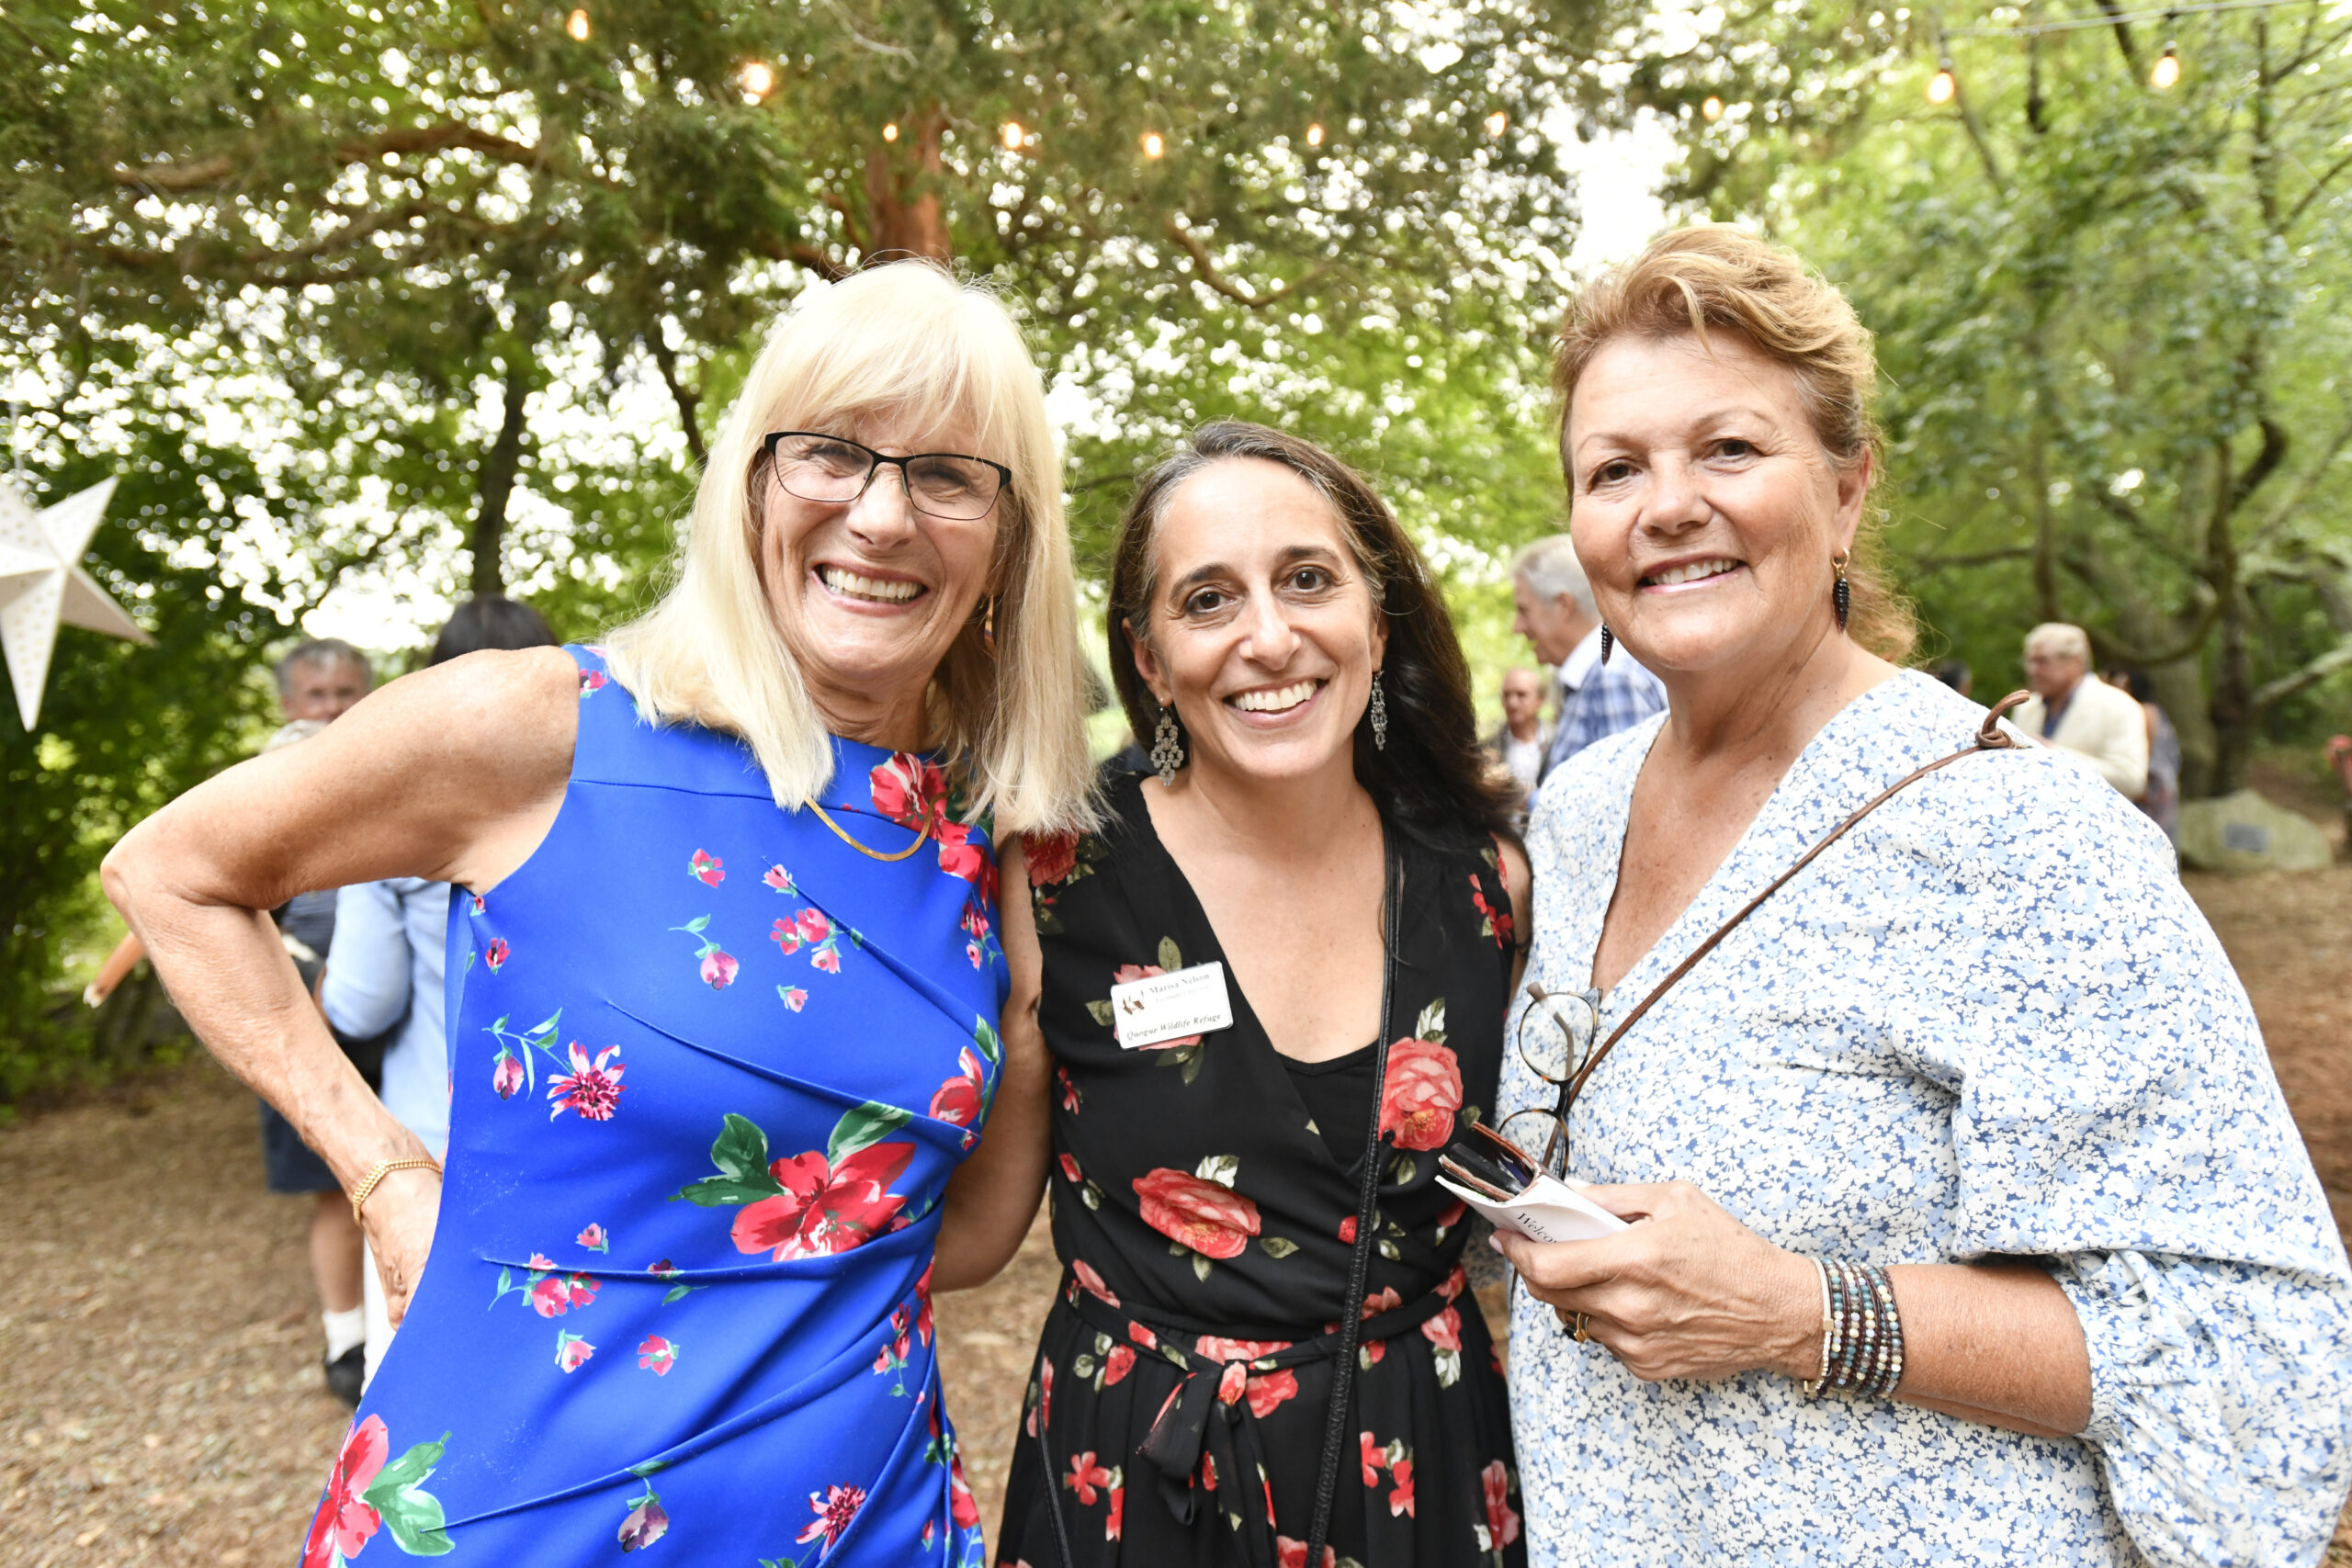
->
xmin=1500 ymin=228 xmax=2352 ymax=1563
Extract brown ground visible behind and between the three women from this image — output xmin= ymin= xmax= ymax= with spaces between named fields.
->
xmin=0 ymin=867 xmax=2352 ymax=1568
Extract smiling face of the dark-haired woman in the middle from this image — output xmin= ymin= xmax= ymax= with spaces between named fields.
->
xmin=1129 ymin=458 xmax=1387 ymax=778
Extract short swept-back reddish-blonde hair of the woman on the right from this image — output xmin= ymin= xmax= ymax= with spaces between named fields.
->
xmin=1553 ymin=223 xmax=1919 ymax=663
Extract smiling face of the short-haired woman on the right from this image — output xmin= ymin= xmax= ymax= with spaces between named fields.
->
xmin=1564 ymin=332 xmax=1870 ymax=677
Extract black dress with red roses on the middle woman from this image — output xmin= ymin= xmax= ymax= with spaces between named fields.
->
xmin=997 ymin=771 xmax=1524 ymax=1568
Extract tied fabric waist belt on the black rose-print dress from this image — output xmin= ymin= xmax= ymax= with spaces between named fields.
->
xmin=1046 ymin=1272 xmax=1453 ymax=1568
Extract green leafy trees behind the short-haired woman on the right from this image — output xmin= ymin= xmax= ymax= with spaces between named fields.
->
xmin=1580 ymin=5 xmax=2352 ymax=792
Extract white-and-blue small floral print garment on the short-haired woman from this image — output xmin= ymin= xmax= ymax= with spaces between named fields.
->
xmin=1500 ymin=672 xmax=2352 ymax=1565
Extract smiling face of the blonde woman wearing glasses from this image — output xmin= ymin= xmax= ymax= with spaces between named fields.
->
xmin=752 ymin=413 xmax=1004 ymax=745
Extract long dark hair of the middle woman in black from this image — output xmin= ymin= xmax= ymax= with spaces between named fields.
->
xmin=1108 ymin=419 xmax=1520 ymax=844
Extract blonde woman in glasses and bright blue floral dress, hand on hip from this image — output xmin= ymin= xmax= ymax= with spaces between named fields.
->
xmin=106 ymin=264 xmax=1089 ymax=1568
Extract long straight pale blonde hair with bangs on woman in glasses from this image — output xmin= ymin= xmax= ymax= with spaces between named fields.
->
xmin=605 ymin=261 xmax=1093 ymax=835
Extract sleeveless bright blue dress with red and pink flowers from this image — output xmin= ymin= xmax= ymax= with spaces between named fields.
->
xmin=303 ymin=649 xmax=1004 ymax=1568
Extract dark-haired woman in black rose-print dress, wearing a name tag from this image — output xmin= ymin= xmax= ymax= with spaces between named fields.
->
xmin=988 ymin=423 xmax=1526 ymax=1568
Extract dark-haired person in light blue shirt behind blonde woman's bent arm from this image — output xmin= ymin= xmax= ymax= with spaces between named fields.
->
xmin=320 ymin=594 xmax=555 ymax=1378
